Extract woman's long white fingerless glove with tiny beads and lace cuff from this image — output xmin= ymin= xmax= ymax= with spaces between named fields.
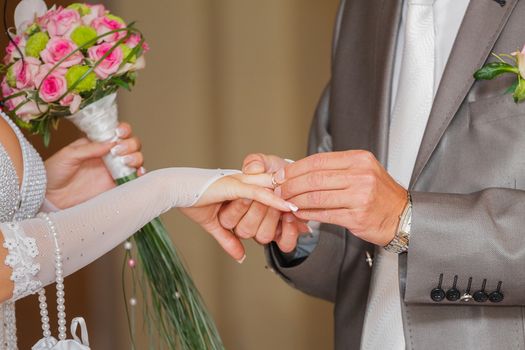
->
xmin=0 ymin=168 xmax=290 ymax=300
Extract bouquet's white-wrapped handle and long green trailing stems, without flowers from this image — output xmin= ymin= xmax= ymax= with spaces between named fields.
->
xmin=67 ymin=93 xmax=224 ymax=350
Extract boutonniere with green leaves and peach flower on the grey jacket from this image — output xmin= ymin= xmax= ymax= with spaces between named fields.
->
xmin=474 ymin=47 xmax=525 ymax=103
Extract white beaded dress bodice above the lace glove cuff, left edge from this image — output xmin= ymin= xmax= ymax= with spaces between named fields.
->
xmin=0 ymin=111 xmax=46 ymax=350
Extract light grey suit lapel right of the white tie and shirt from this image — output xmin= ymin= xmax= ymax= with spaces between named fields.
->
xmin=410 ymin=0 xmax=518 ymax=187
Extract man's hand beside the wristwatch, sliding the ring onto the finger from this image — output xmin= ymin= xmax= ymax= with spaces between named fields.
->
xmin=275 ymin=151 xmax=408 ymax=246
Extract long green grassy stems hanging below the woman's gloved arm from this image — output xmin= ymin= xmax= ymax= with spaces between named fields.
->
xmin=116 ymin=174 xmax=224 ymax=350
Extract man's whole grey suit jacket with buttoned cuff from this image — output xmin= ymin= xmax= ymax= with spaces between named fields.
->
xmin=267 ymin=0 xmax=525 ymax=350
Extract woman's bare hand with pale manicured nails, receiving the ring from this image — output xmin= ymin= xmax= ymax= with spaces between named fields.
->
xmin=181 ymin=174 xmax=297 ymax=263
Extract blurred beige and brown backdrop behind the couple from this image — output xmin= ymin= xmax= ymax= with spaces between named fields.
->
xmin=4 ymin=0 xmax=338 ymax=350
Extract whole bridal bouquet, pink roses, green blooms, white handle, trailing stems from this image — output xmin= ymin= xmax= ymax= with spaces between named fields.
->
xmin=1 ymin=0 xmax=223 ymax=350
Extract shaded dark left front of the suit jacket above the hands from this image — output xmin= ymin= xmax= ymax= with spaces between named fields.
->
xmin=330 ymin=0 xmax=402 ymax=162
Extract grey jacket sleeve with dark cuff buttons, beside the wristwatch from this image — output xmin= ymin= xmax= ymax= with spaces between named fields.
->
xmin=404 ymin=188 xmax=525 ymax=306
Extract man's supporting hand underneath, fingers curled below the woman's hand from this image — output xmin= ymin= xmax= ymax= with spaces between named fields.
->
xmin=219 ymin=153 xmax=308 ymax=253
